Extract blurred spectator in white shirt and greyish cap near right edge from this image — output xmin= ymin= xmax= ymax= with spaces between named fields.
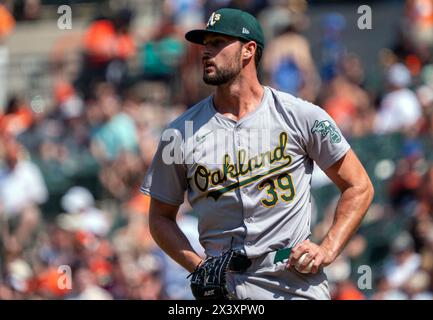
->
xmin=374 ymin=63 xmax=422 ymax=134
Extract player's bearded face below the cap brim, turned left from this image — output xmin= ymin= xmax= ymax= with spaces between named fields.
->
xmin=202 ymin=35 xmax=242 ymax=86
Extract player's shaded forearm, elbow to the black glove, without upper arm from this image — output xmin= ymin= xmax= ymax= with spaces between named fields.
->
xmin=149 ymin=215 xmax=202 ymax=272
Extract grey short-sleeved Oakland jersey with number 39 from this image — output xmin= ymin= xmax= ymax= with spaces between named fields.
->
xmin=141 ymin=87 xmax=350 ymax=258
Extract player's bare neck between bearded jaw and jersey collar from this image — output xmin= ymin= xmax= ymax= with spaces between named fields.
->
xmin=213 ymin=77 xmax=264 ymax=121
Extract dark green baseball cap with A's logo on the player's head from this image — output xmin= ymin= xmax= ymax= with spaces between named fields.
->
xmin=185 ymin=8 xmax=265 ymax=49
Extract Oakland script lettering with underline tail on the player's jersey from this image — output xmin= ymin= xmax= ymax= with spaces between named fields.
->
xmin=194 ymin=132 xmax=292 ymax=200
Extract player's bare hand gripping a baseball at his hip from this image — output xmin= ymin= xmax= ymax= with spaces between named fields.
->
xmin=287 ymin=239 xmax=335 ymax=273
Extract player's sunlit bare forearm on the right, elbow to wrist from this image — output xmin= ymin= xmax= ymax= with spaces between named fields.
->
xmin=320 ymin=181 xmax=374 ymax=261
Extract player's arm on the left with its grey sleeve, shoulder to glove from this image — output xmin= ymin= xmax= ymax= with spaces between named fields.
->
xmin=140 ymin=123 xmax=201 ymax=272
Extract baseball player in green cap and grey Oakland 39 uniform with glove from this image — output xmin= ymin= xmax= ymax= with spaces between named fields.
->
xmin=141 ymin=8 xmax=373 ymax=299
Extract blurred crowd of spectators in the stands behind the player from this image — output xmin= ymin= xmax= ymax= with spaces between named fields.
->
xmin=0 ymin=0 xmax=433 ymax=300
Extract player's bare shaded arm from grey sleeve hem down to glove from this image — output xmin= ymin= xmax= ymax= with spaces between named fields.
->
xmin=149 ymin=198 xmax=202 ymax=272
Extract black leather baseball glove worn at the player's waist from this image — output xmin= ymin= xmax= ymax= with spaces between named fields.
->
xmin=188 ymin=250 xmax=234 ymax=300
